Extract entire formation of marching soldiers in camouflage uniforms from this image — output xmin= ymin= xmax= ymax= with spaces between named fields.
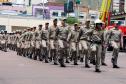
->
xmin=0 ymin=19 xmax=122 ymax=72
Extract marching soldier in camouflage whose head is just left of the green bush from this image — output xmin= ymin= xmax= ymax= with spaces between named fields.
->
xmin=56 ymin=19 xmax=69 ymax=67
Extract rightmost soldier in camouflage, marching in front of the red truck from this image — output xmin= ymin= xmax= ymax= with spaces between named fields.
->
xmin=110 ymin=23 xmax=122 ymax=68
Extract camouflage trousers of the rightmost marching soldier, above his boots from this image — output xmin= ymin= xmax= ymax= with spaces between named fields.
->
xmin=111 ymin=41 xmax=120 ymax=65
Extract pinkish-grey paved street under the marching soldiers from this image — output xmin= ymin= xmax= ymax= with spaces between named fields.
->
xmin=0 ymin=51 xmax=126 ymax=84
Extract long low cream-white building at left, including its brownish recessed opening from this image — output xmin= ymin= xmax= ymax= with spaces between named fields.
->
xmin=0 ymin=15 xmax=53 ymax=33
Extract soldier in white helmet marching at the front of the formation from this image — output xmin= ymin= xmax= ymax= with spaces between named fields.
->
xmin=91 ymin=19 xmax=103 ymax=72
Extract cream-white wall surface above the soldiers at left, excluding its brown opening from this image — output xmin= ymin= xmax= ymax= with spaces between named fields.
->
xmin=0 ymin=15 xmax=52 ymax=32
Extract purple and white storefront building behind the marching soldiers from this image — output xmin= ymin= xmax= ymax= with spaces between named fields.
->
xmin=32 ymin=3 xmax=66 ymax=19
